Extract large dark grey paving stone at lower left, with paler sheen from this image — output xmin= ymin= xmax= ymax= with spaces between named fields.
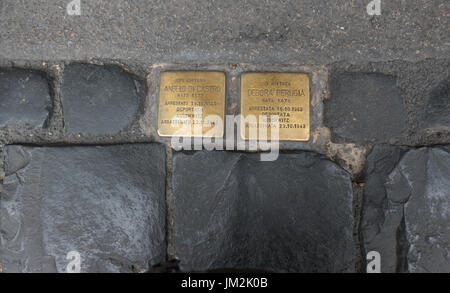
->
xmin=0 ymin=144 xmax=165 ymax=272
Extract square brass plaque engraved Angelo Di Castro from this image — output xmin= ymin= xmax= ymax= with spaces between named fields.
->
xmin=158 ymin=71 xmax=225 ymax=137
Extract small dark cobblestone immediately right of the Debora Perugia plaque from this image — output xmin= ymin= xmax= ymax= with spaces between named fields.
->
xmin=325 ymin=73 xmax=406 ymax=142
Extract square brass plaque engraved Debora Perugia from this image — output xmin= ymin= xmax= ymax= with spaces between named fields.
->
xmin=241 ymin=72 xmax=309 ymax=141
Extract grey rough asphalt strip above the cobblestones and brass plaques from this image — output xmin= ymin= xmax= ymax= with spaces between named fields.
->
xmin=0 ymin=0 xmax=450 ymax=64
